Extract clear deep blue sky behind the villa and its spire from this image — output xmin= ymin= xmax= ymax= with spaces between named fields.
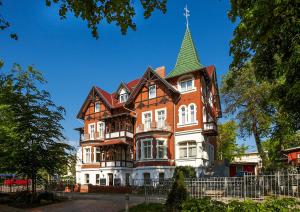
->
xmin=0 ymin=0 xmax=254 ymax=149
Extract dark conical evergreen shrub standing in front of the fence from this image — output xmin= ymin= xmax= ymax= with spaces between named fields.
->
xmin=166 ymin=171 xmax=188 ymax=211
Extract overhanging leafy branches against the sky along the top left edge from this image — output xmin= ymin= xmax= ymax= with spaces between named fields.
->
xmin=0 ymin=0 xmax=167 ymax=39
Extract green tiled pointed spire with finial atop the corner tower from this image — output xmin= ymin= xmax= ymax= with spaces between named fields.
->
xmin=168 ymin=6 xmax=203 ymax=78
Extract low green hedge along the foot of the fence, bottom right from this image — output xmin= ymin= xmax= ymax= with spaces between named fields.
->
xmin=181 ymin=197 xmax=300 ymax=212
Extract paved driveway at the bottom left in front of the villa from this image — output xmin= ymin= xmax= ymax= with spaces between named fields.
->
xmin=0 ymin=193 xmax=144 ymax=212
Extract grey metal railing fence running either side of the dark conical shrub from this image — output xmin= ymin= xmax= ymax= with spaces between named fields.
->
xmin=135 ymin=174 xmax=300 ymax=202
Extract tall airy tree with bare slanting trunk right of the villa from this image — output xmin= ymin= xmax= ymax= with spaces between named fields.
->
xmin=221 ymin=63 xmax=272 ymax=167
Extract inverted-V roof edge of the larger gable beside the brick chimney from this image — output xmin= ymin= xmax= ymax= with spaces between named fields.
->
xmin=126 ymin=67 xmax=180 ymax=104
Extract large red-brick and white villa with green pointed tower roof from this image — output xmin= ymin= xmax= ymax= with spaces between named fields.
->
xmin=76 ymin=27 xmax=221 ymax=185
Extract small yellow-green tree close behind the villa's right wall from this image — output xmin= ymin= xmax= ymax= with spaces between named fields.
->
xmin=217 ymin=121 xmax=247 ymax=162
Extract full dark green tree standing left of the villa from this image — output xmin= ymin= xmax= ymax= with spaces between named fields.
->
xmin=0 ymin=62 xmax=73 ymax=192
